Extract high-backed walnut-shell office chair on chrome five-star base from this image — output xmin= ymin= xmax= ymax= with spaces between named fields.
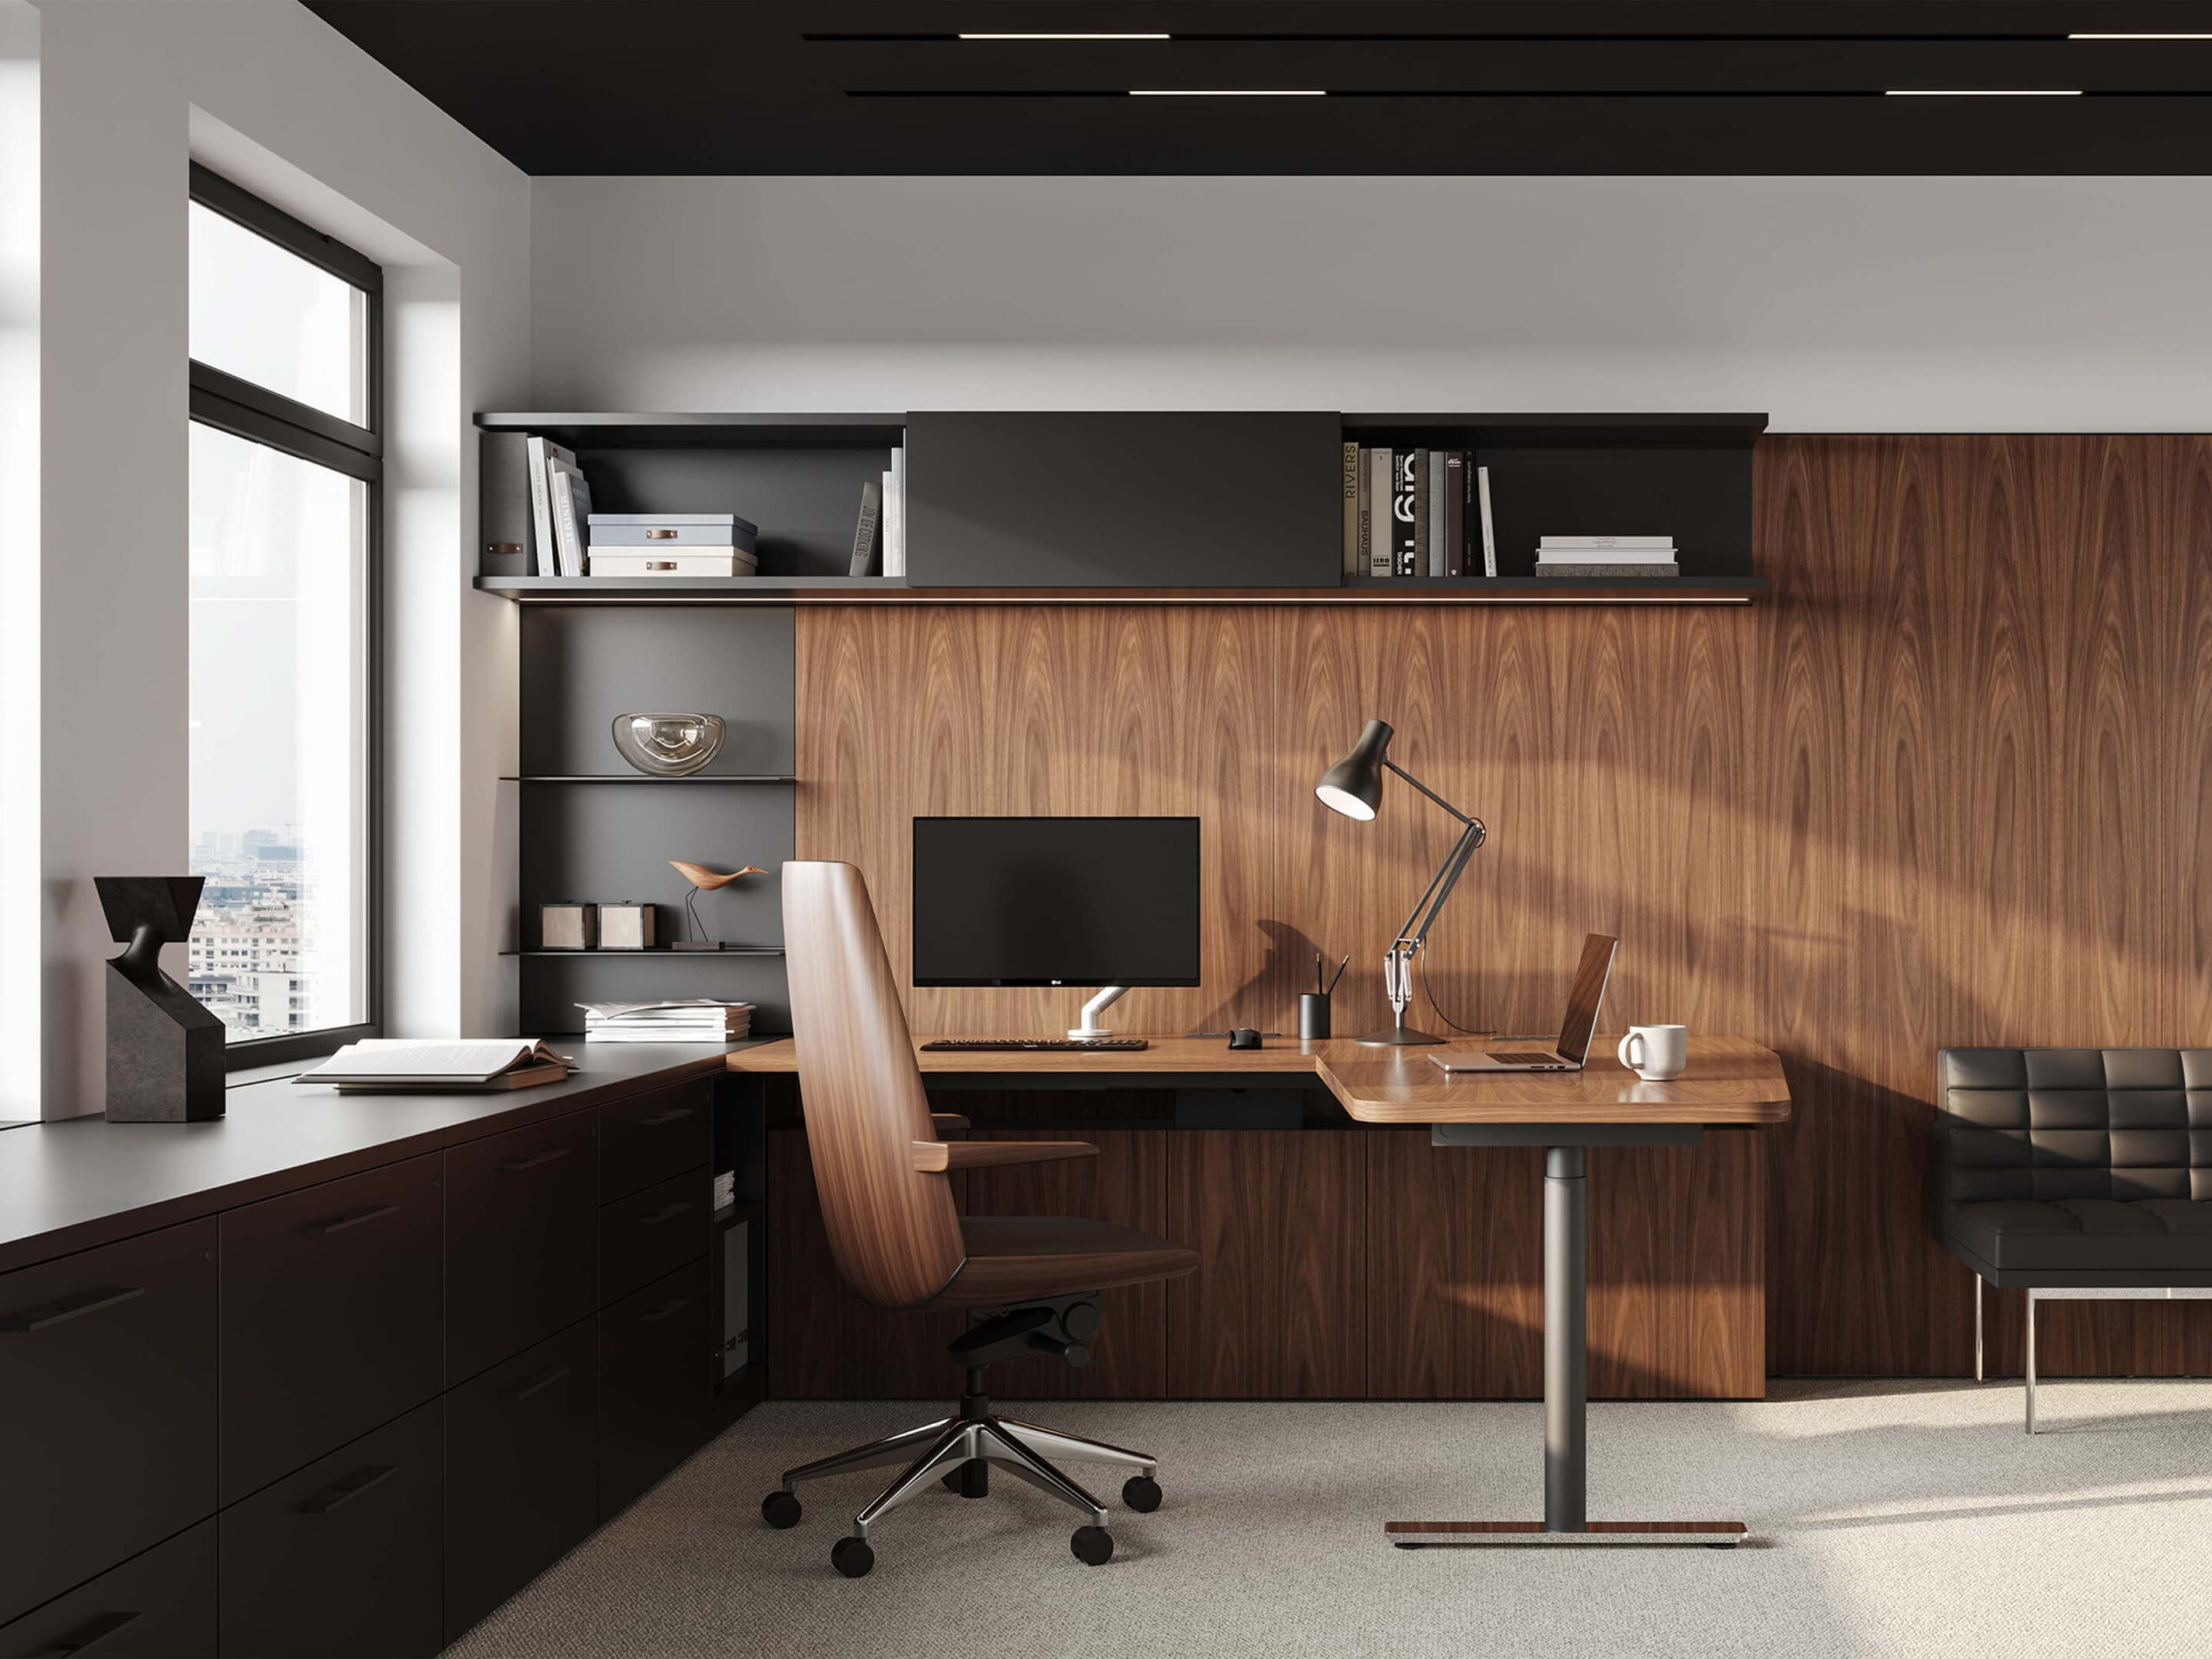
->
xmin=761 ymin=862 xmax=1199 ymax=1577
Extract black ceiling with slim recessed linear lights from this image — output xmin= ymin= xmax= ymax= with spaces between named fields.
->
xmin=305 ymin=0 xmax=2212 ymax=175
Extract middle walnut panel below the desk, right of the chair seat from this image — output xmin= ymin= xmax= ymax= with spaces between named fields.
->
xmin=1166 ymin=1130 xmax=1376 ymax=1400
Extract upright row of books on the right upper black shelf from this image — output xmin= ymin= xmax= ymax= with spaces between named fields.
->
xmin=1343 ymin=445 xmax=1497 ymax=577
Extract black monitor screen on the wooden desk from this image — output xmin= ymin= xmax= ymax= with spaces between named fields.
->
xmin=913 ymin=818 xmax=1199 ymax=984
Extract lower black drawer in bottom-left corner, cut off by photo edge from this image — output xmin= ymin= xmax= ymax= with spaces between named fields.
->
xmin=0 ymin=1517 xmax=214 ymax=1659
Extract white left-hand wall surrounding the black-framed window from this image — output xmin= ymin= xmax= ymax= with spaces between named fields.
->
xmin=22 ymin=0 xmax=531 ymax=1117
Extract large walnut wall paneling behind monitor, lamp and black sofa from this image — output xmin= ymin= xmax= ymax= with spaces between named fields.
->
xmin=797 ymin=435 xmax=2212 ymax=1394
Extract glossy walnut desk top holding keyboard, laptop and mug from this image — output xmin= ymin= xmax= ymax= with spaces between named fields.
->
xmin=728 ymin=1035 xmax=1789 ymax=1123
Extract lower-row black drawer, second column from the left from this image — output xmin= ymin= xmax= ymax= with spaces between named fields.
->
xmin=217 ymin=1400 xmax=445 ymax=1659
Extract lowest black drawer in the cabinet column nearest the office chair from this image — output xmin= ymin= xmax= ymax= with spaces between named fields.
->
xmin=600 ymin=1259 xmax=712 ymax=1522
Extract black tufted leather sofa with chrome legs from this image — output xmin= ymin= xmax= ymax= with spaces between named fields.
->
xmin=1936 ymin=1048 xmax=2212 ymax=1433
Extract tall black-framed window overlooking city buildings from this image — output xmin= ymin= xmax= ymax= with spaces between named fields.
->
xmin=188 ymin=166 xmax=383 ymax=1064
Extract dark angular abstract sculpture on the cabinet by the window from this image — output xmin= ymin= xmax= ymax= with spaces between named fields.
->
xmin=93 ymin=876 xmax=226 ymax=1123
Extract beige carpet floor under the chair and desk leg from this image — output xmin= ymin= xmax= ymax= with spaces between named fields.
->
xmin=451 ymin=1382 xmax=2212 ymax=1659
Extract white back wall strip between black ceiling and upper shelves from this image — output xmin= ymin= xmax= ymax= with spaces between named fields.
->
xmin=533 ymin=179 xmax=2212 ymax=431
